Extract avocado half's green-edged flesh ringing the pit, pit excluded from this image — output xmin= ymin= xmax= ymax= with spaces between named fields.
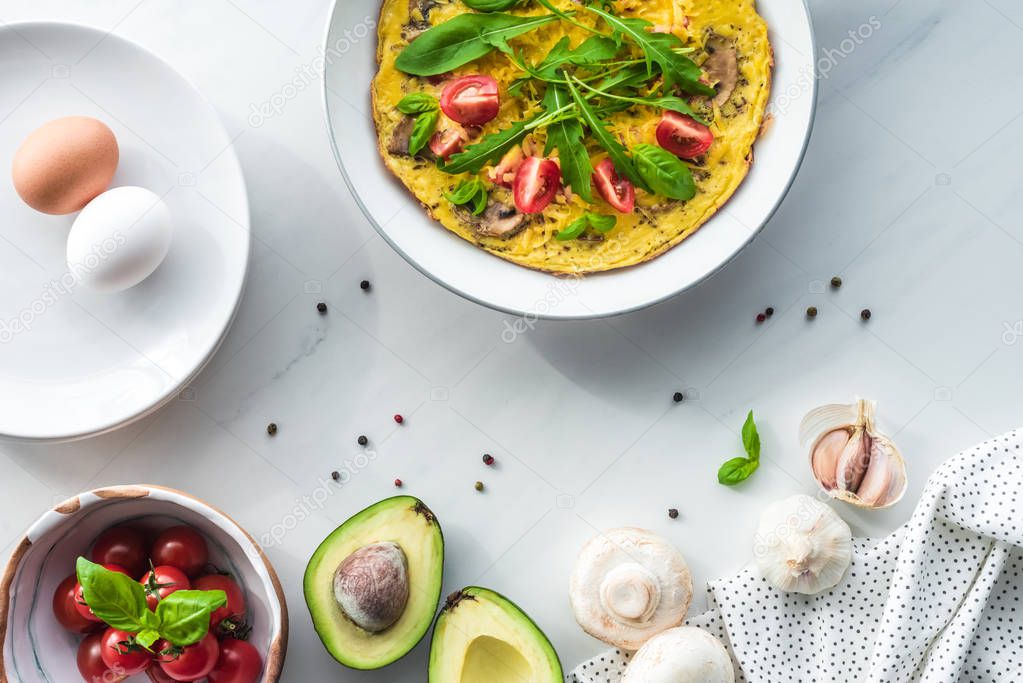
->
xmin=303 ymin=496 xmax=444 ymax=670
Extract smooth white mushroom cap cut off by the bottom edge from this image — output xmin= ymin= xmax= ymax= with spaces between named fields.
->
xmin=622 ymin=626 xmax=736 ymax=683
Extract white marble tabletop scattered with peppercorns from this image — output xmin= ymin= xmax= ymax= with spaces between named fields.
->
xmin=0 ymin=0 xmax=1023 ymax=681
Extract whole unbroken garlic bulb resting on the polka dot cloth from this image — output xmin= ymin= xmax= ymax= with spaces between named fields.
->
xmin=753 ymin=496 xmax=852 ymax=595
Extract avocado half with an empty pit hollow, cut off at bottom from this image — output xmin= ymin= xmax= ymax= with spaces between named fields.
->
xmin=430 ymin=586 xmax=565 ymax=683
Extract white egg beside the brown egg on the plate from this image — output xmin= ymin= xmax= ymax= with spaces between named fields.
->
xmin=68 ymin=187 xmax=173 ymax=292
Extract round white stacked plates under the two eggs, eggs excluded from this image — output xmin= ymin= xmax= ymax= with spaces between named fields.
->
xmin=0 ymin=22 xmax=250 ymax=441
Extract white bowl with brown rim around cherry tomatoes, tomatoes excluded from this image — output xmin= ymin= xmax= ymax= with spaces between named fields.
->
xmin=0 ymin=485 xmax=287 ymax=683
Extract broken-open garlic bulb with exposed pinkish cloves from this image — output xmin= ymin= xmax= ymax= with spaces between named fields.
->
xmin=799 ymin=400 xmax=906 ymax=508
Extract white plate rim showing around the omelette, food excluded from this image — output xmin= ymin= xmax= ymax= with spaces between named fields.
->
xmin=324 ymin=0 xmax=816 ymax=319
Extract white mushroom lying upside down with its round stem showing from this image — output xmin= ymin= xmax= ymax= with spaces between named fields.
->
xmin=569 ymin=529 xmax=693 ymax=650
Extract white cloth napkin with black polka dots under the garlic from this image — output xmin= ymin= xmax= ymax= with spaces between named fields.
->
xmin=568 ymin=432 xmax=1023 ymax=683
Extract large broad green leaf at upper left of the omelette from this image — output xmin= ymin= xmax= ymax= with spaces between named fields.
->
xmin=395 ymin=13 xmax=558 ymax=76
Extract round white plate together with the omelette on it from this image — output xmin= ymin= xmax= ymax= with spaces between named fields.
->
xmin=324 ymin=0 xmax=816 ymax=319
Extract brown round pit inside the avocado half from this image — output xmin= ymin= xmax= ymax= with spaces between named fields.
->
xmin=333 ymin=541 xmax=408 ymax=633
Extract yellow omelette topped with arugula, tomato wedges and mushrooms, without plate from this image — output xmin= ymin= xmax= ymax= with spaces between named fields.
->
xmin=372 ymin=0 xmax=773 ymax=274
